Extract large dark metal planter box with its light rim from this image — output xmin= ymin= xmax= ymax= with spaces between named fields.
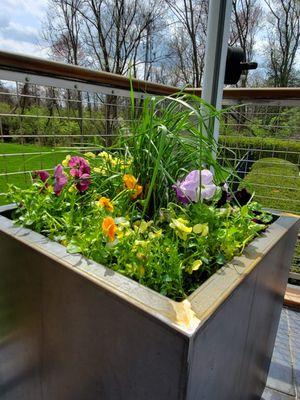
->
xmin=0 ymin=207 xmax=299 ymax=400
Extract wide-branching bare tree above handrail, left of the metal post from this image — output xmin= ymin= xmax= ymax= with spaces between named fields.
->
xmin=72 ymin=0 xmax=162 ymax=74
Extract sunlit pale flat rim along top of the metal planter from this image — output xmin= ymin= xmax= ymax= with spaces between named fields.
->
xmin=0 ymin=204 xmax=300 ymax=338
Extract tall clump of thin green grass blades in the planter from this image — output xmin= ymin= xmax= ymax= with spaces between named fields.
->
xmin=116 ymin=95 xmax=227 ymax=216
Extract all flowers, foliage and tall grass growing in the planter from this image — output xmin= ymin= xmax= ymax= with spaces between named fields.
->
xmin=8 ymin=96 xmax=272 ymax=300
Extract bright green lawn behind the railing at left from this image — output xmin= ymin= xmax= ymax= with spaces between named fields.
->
xmin=0 ymin=143 xmax=73 ymax=204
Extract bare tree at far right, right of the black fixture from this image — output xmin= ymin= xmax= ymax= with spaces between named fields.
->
xmin=265 ymin=0 xmax=300 ymax=87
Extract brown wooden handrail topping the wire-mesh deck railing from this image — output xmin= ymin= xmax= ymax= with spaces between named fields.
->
xmin=0 ymin=51 xmax=300 ymax=100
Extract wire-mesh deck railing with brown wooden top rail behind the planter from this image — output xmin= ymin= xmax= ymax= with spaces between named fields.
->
xmin=0 ymin=52 xmax=300 ymax=280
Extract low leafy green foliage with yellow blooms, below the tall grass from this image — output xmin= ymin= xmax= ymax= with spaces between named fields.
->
xmin=9 ymin=171 xmax=272 ymax=300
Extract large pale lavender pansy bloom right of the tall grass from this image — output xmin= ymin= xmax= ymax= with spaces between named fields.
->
xmin=172 ymin=169 xmax=217 ymax=204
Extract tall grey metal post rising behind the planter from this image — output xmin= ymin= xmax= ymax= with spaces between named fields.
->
xmin=202 ymin=0 xmax=232 ymax=141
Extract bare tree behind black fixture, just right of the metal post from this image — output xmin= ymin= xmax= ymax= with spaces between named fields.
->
xmin=229 ymin=0 xmax=262 ymax=87
